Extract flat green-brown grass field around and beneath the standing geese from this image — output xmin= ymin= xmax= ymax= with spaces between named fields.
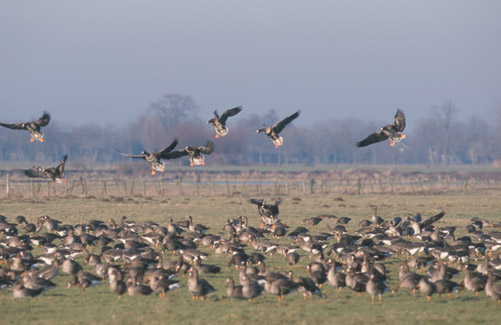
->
xmin=0 ymin=171 xmax=501 ymax=324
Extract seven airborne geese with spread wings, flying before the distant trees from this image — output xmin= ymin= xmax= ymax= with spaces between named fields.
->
xmin=0 ymin=106 xmax=405 ymax=184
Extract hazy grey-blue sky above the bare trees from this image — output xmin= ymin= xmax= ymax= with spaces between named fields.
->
xmin=0 ymin=0 xmax=501 ymax=126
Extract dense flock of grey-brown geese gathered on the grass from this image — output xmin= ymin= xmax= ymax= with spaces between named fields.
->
xmin=0 ymin=204 xmax=501 ymax=303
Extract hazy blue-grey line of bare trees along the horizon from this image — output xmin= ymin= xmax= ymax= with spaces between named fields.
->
xmin=0 ymin=94 xmax=501 ymax=167
